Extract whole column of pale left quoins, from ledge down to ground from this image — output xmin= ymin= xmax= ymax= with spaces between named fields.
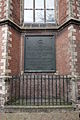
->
xmin=0 ymin=25 xmax=12 ymax=108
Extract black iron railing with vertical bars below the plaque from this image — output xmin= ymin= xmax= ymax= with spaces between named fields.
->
xmin=6 ymin=74 xmax=71 ymax=106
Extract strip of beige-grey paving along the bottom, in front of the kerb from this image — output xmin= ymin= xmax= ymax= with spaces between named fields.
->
xmin=0 ymin=111 xmax=79 ymax=120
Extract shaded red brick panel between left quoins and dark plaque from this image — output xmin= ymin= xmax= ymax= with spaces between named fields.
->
xmin=8 ymin=27 xmax=21 ymax=75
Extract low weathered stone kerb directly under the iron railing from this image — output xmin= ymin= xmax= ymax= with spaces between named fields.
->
xmin=4 ymin=105 xmax=74 ymax=113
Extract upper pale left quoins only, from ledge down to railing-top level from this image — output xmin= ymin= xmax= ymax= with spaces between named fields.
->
xmin=0 ymin=25 xmax=12 ymax=76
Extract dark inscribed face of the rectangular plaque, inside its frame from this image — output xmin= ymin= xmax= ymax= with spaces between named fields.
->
xmin=24 ymin=36 xmax=55 ymax=71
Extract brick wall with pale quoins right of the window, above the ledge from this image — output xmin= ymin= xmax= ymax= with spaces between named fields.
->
xmin=58 ymin=0 xmax=80 ymax=24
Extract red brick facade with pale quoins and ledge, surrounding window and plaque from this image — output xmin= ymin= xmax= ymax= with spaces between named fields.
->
xmin=0 ymin=0 xmax=80 ymax=109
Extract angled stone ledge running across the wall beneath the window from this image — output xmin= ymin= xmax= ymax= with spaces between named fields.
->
xmin=0 ymin=17 xmax=80 ymax=33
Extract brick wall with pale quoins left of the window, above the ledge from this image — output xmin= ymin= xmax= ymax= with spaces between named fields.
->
xmin=0 ymin=0 xmax=20 ymax=24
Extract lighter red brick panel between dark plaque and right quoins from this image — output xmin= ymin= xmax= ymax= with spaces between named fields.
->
xmin=56 ymin=28 xmax=70 ymax=75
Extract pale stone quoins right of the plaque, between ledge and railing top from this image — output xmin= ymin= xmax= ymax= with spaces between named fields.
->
xmin=68 ymin=25 xmax=78 ymax=77
